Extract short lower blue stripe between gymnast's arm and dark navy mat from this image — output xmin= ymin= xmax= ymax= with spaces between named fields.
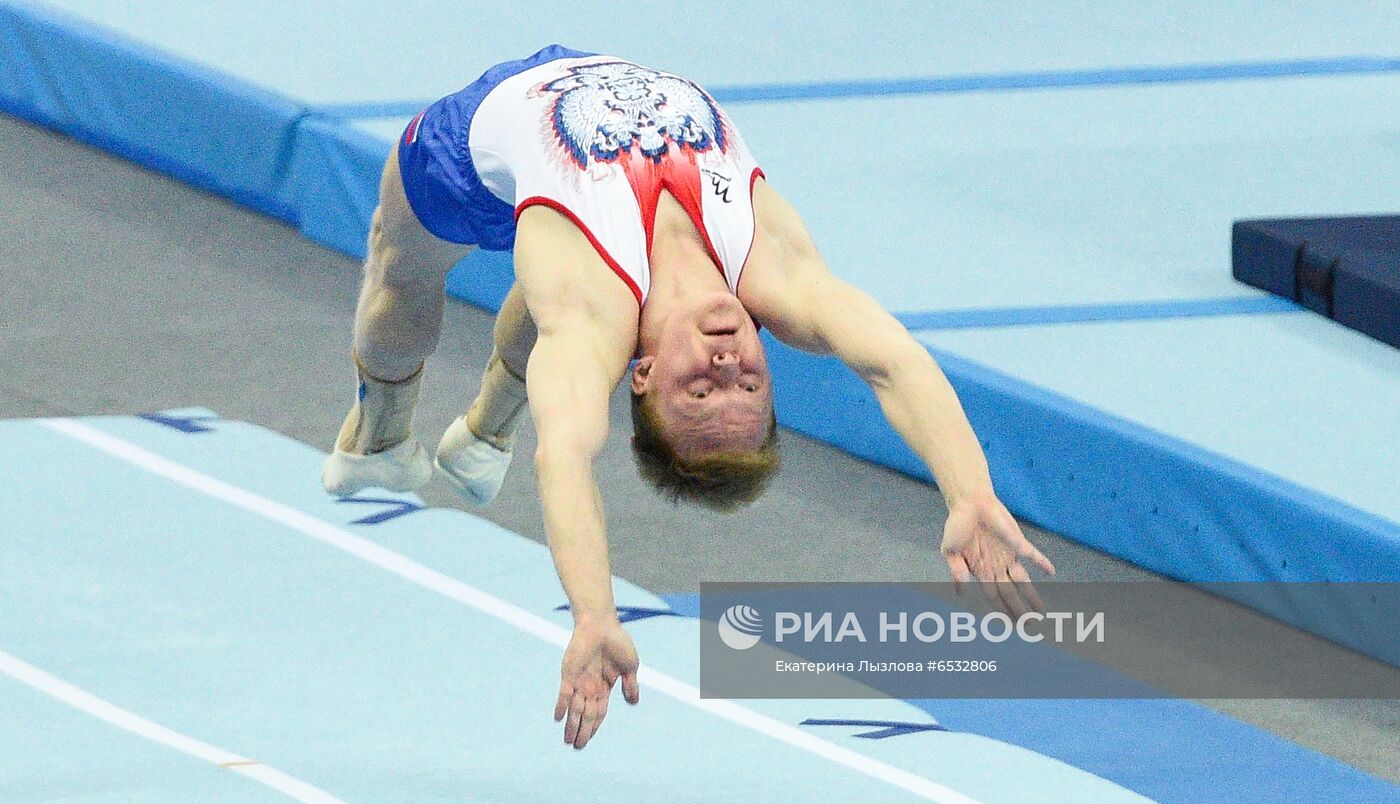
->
xmin=895 ymin=296 xmax=1302 ymax=331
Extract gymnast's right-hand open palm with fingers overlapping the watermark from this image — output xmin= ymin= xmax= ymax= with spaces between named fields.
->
xmin=941 ymin=492 xmax=1054 ymax=616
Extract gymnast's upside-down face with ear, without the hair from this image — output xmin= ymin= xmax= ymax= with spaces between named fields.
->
xmin=631 ymin=291 xmax=773 ymax=459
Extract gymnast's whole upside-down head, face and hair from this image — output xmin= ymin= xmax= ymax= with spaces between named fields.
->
xmin=631 ymin=291 xmax=778 ymax=511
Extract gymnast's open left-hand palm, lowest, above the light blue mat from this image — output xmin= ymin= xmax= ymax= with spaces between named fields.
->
xmin=554 ymin=618 xmax=641 ymax=748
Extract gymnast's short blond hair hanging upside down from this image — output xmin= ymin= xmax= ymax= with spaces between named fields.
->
xmin=631 ymin=394 xmax=778 ymax=513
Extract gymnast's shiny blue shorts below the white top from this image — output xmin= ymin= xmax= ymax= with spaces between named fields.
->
xmin=399 ymin=45 xmax=595 ymax=251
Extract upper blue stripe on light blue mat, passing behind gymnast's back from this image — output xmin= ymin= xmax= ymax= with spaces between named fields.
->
xmin=311 ymin=56 xmax=1400 ymax=119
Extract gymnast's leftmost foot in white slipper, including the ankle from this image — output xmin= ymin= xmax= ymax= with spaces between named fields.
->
xmin=321 ymin=357 xmax=433 ymax=496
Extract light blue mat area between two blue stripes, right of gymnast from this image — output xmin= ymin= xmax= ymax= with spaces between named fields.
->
xmin=732 ymin=77 xmax=1400 ymax=311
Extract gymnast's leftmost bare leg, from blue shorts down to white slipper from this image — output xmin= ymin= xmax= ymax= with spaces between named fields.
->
xmin=321 ymin=147 xmax=472 ymax=494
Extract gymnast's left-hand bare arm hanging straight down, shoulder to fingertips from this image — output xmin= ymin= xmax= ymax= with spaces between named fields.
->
xmin=515 ymin=207 xmax=638 ymax=748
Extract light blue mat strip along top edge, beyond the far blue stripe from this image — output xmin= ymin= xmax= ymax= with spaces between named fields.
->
xmin=21 ymin=0 xmax=1400 ymax=105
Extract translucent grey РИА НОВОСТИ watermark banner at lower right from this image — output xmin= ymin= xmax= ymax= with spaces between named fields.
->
xmin=700 ymin=583 xmax=1400 ymax=698
